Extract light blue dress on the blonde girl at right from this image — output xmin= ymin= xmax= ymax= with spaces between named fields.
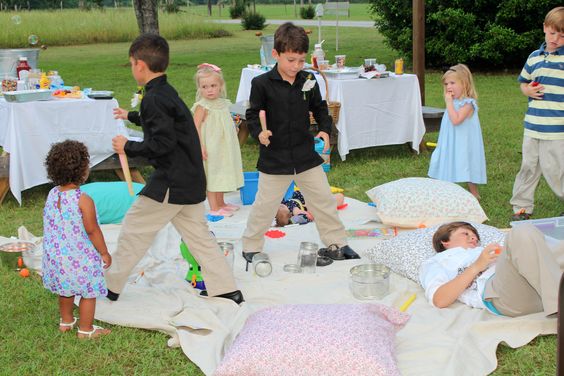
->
xmin=428 ymin=98 xmax=487 ymax=184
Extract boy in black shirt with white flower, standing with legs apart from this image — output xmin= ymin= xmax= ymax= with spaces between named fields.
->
xmin=243 ymin=22 xmax=359 ymax=262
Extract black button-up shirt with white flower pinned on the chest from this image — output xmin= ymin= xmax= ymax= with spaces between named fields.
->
xmin=246 ymin=65 xmax=332 ymax=175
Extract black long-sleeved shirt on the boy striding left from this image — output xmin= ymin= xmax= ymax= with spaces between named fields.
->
xmin=125 ymin=75 xmax=206 ymax=205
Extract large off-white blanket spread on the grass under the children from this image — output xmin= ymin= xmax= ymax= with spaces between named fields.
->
xmin=11 ymin=196 xmax=556 ymax=376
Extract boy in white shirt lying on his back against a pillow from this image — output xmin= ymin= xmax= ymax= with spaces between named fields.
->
xmin=419 ymin=222 xmax=564 ymax=317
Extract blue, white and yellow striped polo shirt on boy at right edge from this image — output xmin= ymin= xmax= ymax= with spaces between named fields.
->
xmin=518 ymin=43 xmax=564 ymax=140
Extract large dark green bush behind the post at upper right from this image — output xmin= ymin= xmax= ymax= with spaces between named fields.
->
xmin=369 ymin=0 xmax=561 ymax=68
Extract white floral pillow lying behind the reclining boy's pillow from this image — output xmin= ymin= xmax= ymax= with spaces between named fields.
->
xmin=366 ymin=178 xmax=488 ymax=228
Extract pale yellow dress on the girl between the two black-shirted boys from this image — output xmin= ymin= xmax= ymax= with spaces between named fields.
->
xmin=192 ymin=98 xmax=243 ymax=192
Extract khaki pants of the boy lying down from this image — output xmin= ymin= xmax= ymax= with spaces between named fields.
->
xmin=484 ymin=224 xmax=564 ymax=317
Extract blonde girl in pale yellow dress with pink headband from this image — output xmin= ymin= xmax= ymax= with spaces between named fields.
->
xmin=192 ymin=63 xmax=243 ymax=217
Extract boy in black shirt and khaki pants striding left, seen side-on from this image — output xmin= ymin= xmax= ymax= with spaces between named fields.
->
xmin=106 ymin=34 xmax=243 ymax=304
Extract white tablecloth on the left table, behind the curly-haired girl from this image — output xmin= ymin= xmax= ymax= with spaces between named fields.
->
xmin=0 ymin=98 xmax=128 ymax=204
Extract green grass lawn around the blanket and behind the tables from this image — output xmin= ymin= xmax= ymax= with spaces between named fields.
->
xmin=0 ymin=16 xmax=564 ymax=375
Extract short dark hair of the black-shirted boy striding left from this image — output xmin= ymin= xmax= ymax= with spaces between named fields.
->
xmin=129 ymin=34 xmax=169 ymax=73
